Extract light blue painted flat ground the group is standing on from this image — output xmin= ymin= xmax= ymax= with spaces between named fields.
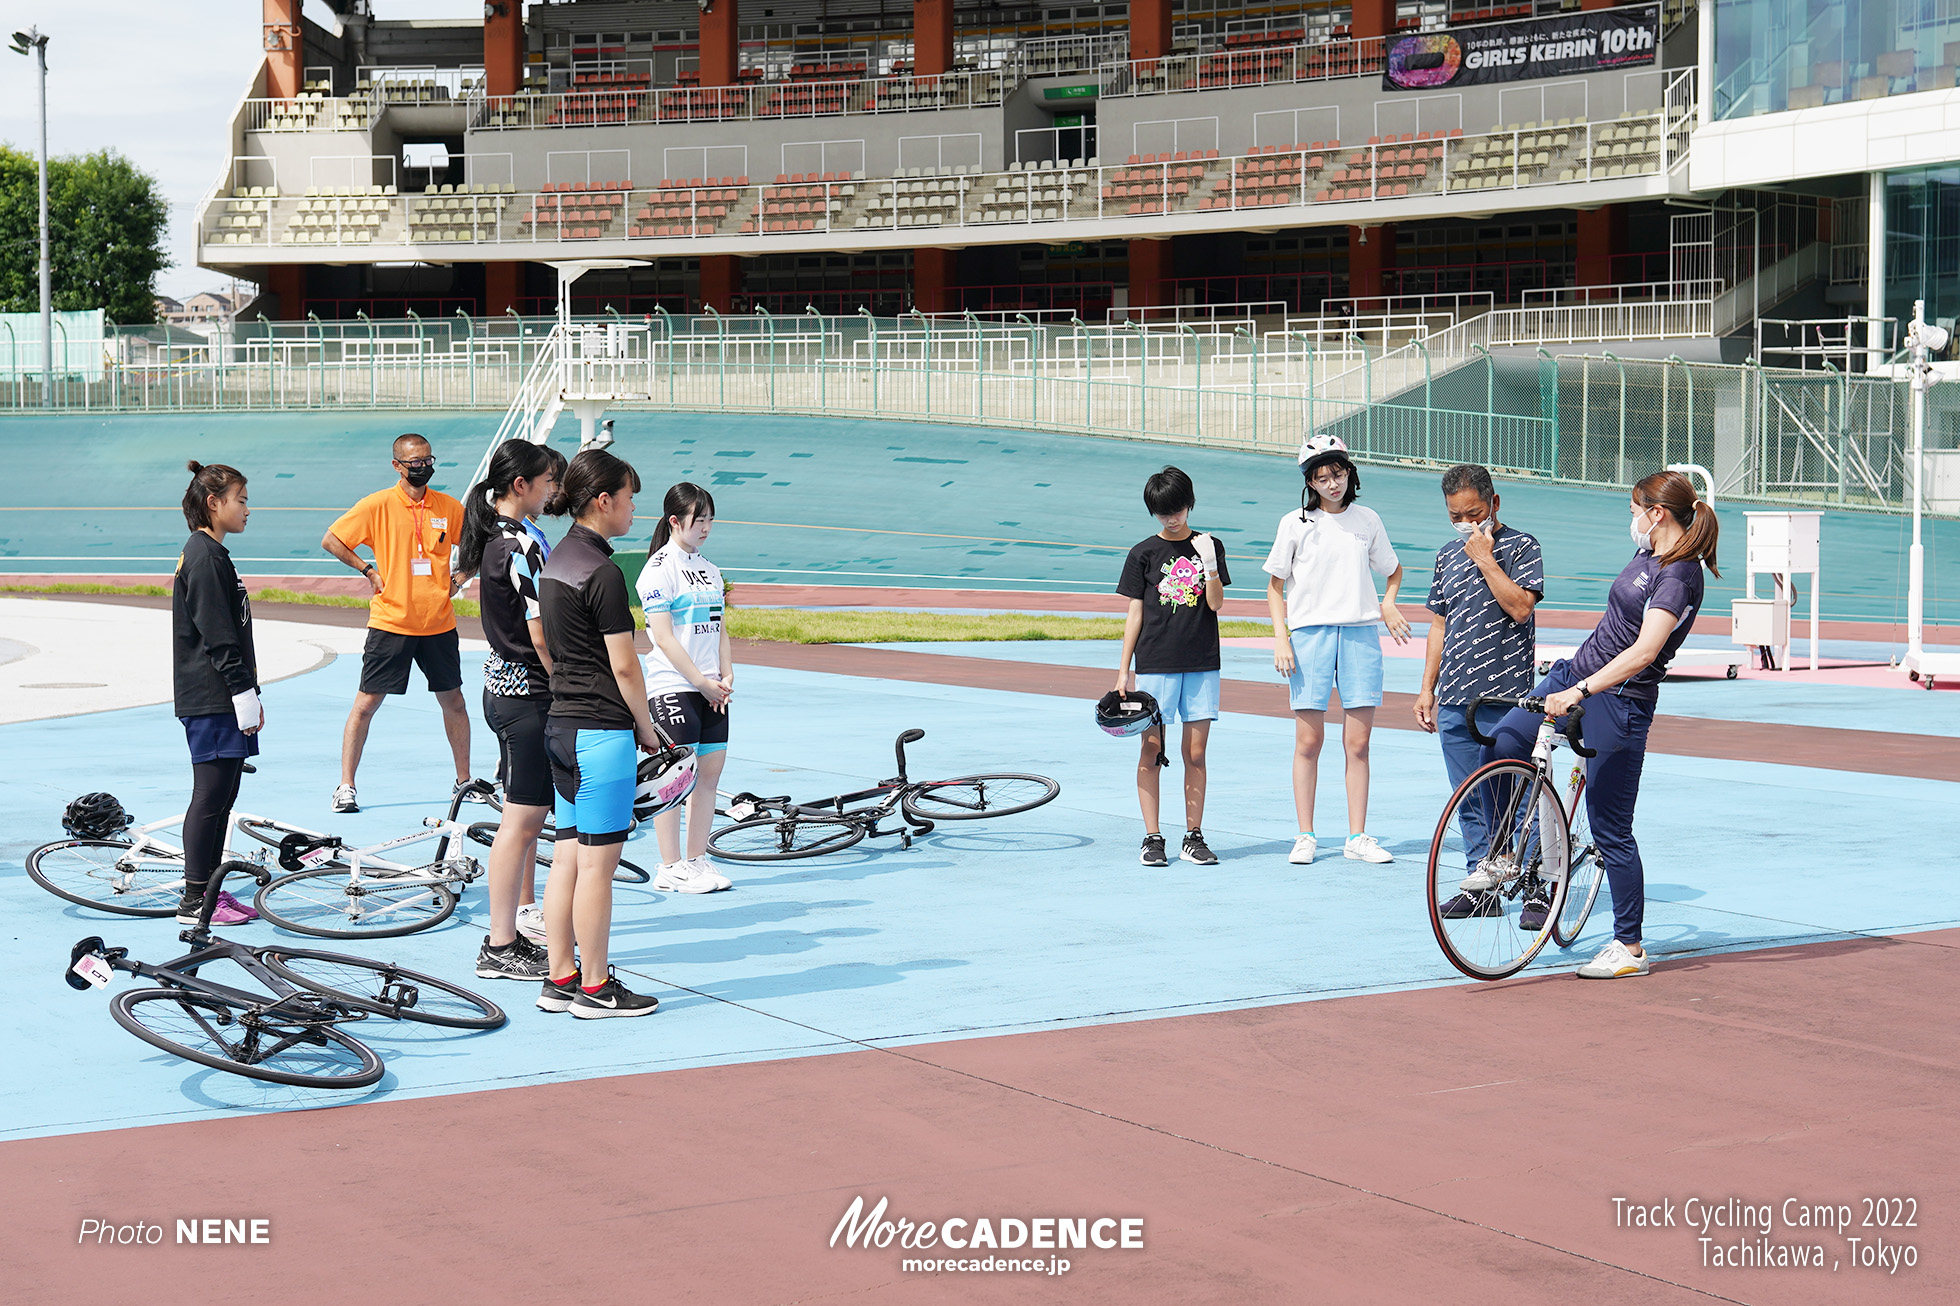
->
xmin=0 ymin=643 xmax=1960 ymax=1137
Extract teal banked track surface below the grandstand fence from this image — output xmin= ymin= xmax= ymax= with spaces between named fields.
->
xmin=0 ymin=412 xmax=1960 ymax=624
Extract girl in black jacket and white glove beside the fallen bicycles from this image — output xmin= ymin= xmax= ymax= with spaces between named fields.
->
xmin=171 ymin=461 xmax=265 ymax=926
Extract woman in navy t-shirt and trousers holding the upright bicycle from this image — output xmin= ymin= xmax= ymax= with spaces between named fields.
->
xmin=1462 ymin=471 xmax=1721 ymax=979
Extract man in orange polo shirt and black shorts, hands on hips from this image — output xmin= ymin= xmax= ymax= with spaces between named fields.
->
xmin=319 ymin=435 xmax=470 ymax=812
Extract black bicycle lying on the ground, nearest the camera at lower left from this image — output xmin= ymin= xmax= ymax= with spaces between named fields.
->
xmin=65 ymin=861 xmax=506 ymax=1088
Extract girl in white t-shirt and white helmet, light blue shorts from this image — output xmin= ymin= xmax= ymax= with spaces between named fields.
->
xmin=1266 ymin=435 xmax=1409 ymax=865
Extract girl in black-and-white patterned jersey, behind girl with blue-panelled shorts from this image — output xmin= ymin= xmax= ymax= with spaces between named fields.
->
xmin=461 ymin=439 xmax=559 ymax=980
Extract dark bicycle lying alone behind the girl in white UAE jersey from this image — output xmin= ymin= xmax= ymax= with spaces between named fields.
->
xmin=708 ymin=729 xmax=1062 ymax=861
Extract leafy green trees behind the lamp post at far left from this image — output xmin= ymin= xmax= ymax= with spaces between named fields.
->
xmin=0 ymin=145 xmax=171 ymax=326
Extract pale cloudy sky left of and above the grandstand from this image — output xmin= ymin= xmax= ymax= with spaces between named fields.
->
xmin=0 ymin=0 xmax=482 ymax=300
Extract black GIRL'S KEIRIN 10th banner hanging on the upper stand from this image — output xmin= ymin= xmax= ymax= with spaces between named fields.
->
xmin=1382 ymin=4 xmax=1660 ymax=90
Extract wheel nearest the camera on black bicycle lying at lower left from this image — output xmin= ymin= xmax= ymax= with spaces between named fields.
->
xmin=110 ymin=988 xmax=386 ymax=1088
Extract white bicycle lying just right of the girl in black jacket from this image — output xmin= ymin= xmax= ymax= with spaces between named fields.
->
xmin=237 ymin=780 xmax=647 ymax=939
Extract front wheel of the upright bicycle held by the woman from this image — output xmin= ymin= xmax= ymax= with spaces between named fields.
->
xmin=1429 ymin=761 xmax=1570 ymax=980
